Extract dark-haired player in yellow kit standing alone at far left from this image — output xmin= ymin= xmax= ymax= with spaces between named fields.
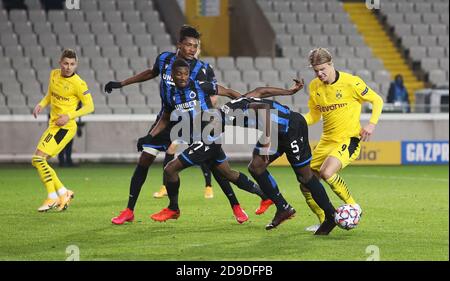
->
xmin=31 ymin=49 xmax=94 ymax=212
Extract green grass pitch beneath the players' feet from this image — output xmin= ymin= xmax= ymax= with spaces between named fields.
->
xmin=0 ymin=164 xmax=449 ymax=261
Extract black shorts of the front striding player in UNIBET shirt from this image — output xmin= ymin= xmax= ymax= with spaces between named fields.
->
xmin=178 ymin=141 xmax=227 ymax=167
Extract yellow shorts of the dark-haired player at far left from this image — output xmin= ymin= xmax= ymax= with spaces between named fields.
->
xmin=37 ymin=124 xmax=77 ymax=157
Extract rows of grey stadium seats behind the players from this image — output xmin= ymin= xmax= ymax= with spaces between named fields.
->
xmin=0 ymin=0 xmax=449 ymax=114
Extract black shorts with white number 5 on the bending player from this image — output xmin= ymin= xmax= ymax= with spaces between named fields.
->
xmin=253 ymin=111 xmax=312 ymax=168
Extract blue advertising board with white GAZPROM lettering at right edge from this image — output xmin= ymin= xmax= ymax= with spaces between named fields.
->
xmin=402 ymin=141 xmax=448 ymax=165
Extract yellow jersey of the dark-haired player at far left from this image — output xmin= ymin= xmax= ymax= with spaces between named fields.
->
xmin=39 ymin=69 xmax=94 ymax=123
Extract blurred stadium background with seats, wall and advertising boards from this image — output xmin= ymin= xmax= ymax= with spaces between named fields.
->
xmin=0 ymin=0 xmax=449 ymax=165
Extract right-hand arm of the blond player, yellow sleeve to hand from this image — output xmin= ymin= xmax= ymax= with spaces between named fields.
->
xmin=354 ymin=77 xmax=383 ymax=141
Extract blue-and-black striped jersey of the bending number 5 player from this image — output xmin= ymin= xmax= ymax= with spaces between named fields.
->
xmin=221 ymin=97 xmax=291 ymax=134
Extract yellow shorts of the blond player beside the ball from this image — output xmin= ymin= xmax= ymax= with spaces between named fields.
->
xmin=311 ymin=137 xmax=361 ymax=171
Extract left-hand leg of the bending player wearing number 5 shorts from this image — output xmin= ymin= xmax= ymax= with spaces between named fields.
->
xmin=248 ymin=152 xmax=295 ymax=230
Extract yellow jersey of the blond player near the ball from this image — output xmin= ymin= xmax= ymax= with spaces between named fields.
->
xmin=305 ymin=72 xmax=383 ymax=141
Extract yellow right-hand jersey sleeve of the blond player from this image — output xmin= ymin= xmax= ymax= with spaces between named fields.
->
xmin=352 ymin=76 xmax=383 ymax=124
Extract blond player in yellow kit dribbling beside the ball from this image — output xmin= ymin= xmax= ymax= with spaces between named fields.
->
xmin=301 ymin=48 xmax=383 ymax=231
